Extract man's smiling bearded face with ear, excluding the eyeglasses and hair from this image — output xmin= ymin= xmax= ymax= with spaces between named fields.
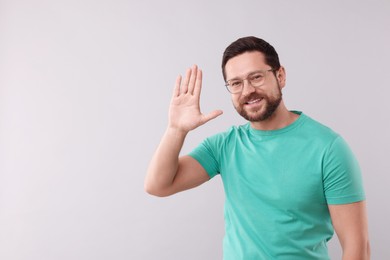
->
xmin=225 ymin=51 xmax=285 ymax=122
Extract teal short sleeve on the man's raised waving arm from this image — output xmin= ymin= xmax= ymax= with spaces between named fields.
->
xmin=188 ymin=136 xmax=220 ymax=178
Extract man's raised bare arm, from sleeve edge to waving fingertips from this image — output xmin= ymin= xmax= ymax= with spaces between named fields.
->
xmin=145 ymin=66 xmax=222 ymax=196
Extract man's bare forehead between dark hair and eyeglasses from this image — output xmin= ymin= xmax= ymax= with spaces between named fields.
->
xmin=225 ymin=51 xmax=269 ymax=79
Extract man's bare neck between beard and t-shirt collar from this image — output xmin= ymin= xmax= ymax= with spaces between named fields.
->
xmin=250 ymin=101 xmax=299 ymax=130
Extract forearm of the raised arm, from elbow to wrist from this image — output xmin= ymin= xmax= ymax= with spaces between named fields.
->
xmin=145 ymin=127 xmax=187 ymax=195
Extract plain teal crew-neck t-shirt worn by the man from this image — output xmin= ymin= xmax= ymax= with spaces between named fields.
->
xmin=189 ymin=112 xmax=365 ymax=260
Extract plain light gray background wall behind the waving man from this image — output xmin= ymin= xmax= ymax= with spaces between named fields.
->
xmin=0 ymin=0 xmax=390 ymax=260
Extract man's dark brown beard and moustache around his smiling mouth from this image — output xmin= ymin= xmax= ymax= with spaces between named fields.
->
xmin=234 ymin=86 xmax=282 ymax=122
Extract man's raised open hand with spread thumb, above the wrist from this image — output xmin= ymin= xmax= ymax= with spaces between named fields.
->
xmin=169 ymin=65 xmax=222 ymax=133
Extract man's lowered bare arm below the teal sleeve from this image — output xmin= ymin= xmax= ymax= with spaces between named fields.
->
xmin=329 ymin=201 xmax=370 ymax=260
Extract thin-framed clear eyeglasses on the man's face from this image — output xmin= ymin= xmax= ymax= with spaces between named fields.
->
xmin=225 ymin=69 xmax=274 ymax=94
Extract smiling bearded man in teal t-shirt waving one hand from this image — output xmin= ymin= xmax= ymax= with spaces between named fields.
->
xmin=145 ymin=37 xmax=369 ymax=260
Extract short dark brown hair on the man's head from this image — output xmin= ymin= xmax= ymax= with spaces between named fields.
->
xmin=222 ymin=36 xmax=280 ymax=80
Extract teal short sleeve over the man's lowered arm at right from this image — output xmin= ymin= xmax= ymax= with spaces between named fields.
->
xmin=323 ymin=136 xmax=365 ymax=204
